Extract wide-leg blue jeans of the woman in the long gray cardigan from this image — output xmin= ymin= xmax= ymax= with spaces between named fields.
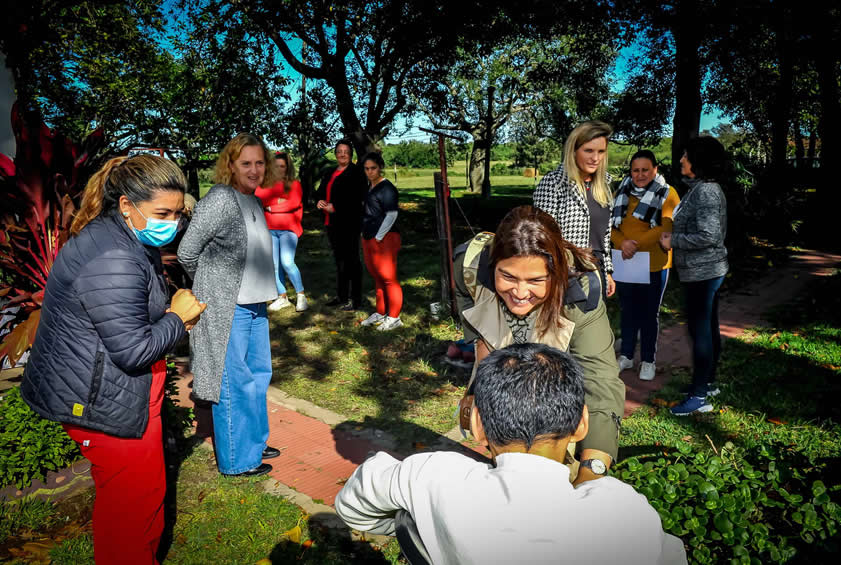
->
xmin=212 ymin=303 xmax=272 ymax=475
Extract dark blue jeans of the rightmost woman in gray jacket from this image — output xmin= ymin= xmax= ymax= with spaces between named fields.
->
xmin=683 ymin=276 xmax=724 ymax=396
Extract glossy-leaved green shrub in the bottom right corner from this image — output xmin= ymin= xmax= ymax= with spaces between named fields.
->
xmin=616 ymin=442 xmax=841 ymax=563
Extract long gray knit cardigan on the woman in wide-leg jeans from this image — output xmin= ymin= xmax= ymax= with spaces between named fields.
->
xmin=178 ymin=184 xmax=248 ymax=402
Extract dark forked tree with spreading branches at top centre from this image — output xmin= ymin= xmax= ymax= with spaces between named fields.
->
xmin=223 ymin=0 xmax=512 ymax=159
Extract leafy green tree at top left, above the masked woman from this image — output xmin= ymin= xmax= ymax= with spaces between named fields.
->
xmin=0 ymin=0 xmax=287 ymax=194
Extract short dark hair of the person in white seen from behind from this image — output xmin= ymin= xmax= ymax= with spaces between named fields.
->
xmin=473 ymin=343 xmax=584 ymax=448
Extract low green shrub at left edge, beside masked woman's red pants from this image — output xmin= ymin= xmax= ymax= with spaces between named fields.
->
xmin=0 ymin=388 xmax=80 ymax=488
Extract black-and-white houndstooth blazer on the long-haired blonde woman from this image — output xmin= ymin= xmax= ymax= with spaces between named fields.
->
xmin=533 ymin=165 xmax=613 ymax=273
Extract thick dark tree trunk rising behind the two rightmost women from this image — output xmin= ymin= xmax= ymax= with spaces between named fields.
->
xmin=672 ymin=0 xmax=702 ymax=179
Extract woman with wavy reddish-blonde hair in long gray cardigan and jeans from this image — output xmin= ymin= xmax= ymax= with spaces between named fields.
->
xmin=178 ymin=133 xmax=280 ymax=476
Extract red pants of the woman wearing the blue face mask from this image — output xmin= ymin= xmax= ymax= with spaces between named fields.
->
xmin=64 ymin=360 xmax=166 ymax=565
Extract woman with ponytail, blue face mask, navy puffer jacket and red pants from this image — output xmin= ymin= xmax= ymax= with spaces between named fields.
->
xmin=21 ymin=155 xmax=205 ymax=565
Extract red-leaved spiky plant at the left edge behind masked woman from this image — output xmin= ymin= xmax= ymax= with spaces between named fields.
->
xmin=0 ymin=104 xmax=104 ymax=366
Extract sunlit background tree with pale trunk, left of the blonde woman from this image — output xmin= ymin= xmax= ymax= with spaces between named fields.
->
xmin=418 ymin=28 xmax=618 ymax=198
